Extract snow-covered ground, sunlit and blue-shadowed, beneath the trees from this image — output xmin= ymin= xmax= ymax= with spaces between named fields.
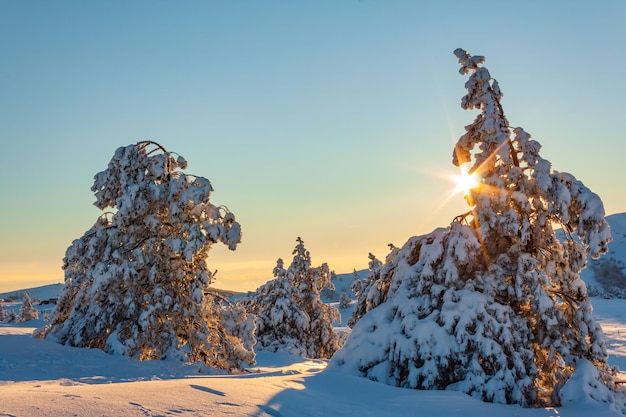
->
xmin=0 ymin=298 xmax=626 ymax=417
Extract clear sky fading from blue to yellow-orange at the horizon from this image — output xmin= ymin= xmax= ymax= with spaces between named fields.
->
xmin=0 ymin=0 xmax=626 ymax=292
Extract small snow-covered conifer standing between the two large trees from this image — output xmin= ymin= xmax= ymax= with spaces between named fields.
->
xmin=246 ymin=238 xmax=341 ymax=358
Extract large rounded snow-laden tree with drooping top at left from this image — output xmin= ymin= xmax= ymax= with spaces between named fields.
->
xmin=38 ymin=141 xmax=254 ymax=369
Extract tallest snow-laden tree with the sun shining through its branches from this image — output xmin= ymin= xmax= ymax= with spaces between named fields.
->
xmin=329 ymin=49 xmax=623 ymax=406
